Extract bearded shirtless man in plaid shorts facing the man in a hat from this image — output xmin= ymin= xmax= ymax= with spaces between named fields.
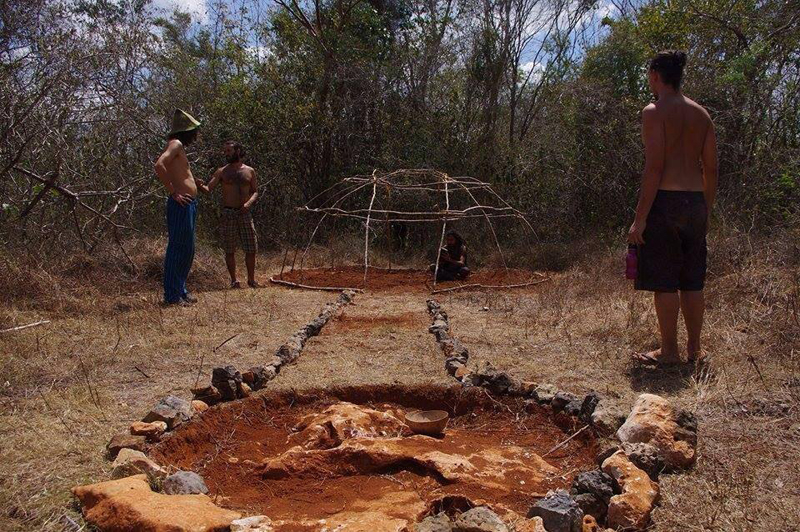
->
xmin=200 ymin=140 xmax=258 ymax=288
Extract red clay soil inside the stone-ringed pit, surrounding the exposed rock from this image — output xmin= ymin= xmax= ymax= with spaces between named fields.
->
xmin=151 ymin=386 xmax=597 ymax=532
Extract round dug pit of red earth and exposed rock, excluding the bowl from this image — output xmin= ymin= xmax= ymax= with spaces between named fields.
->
xmin=150 ymin=386 xmax=597 ymax=532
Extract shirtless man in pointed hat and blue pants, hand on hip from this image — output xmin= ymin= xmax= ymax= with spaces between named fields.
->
xmin=156 ymin=109 xmax=200 ymax=305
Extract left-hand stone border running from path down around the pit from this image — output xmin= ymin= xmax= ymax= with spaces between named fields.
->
xmin=77 ymin=290 xmax=356 ymax=530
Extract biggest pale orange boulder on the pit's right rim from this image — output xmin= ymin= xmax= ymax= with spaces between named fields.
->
xmin=617 ymin=393 xmax=697 ymax=469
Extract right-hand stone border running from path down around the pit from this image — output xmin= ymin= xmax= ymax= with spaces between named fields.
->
xmin=427 ymin=299 xmax=697 ymax=532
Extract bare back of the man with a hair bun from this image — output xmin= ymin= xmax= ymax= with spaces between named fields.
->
xmin=644 ymin=93 xmax=713 ymax=191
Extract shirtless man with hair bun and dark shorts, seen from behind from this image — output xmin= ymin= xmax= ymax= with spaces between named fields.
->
xmin=628 ymin=51 xmax=717 ymax=365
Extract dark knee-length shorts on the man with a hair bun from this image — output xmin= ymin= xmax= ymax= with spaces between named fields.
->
xmin=634 ymin=190 xmax=708 ymax=292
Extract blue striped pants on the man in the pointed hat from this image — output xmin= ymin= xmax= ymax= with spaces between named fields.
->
xmin=164 ymin=196 xmax=197 ymax=303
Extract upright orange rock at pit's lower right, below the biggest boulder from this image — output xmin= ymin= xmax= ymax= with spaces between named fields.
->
xmin=602 ymin=451 xmax=659 ymax=530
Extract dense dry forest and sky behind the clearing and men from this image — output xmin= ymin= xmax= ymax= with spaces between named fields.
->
xmin=0 ymin=0 xmax=800 ymax=275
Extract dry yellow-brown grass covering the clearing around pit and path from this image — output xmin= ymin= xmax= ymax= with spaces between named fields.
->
xmin=0 ymin=234 xmax=800 ymax=532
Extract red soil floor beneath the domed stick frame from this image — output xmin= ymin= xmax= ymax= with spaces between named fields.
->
xmin=276 ymin=266 xmax=538 ymax=292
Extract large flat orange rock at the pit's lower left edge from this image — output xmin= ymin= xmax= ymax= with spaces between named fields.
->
xmin=72 ymin=475 xmax=241 ymax=532
